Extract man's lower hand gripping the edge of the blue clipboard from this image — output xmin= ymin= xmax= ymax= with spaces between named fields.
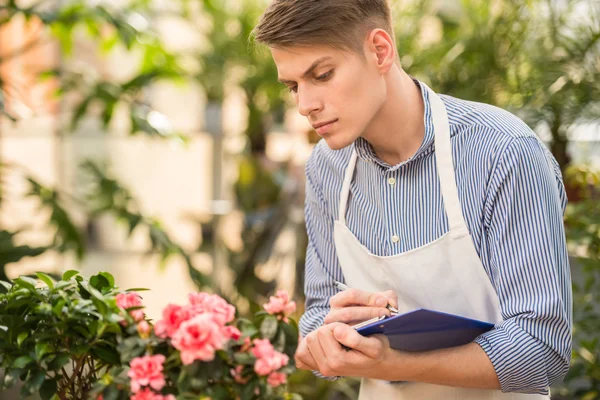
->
xmin=295 ymin=323 xmax=391 ymax=378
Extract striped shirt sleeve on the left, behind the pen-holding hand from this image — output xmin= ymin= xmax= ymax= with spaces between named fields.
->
xmin=299 ymin=147 xmax=343 ymax=380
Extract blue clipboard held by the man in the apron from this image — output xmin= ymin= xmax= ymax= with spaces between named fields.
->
xmin=354 ymin=308 xmax=494 ymax=351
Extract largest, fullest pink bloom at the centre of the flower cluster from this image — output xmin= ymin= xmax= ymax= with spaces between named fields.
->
xmin=172 ymin=314 xmax=227 ymax=365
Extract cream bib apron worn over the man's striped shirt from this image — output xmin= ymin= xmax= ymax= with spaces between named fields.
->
xmin=334 ymin=83 xmax=549 ymax=400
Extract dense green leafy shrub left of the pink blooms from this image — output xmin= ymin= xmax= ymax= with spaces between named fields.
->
xmin=0 ymin=271 xmax=137 ymax=400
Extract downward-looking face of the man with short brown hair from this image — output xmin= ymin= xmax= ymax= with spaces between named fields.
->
xmin=271 ymin=46 xmax=386 ymax=150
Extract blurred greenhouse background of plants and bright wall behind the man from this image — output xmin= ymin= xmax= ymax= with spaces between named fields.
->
xmin=0 ymin=0 xmax=600 ymax=399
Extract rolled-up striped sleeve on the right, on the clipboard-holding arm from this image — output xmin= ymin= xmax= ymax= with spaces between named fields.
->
xmin=476 ymin=137 xmax=572 ymax=394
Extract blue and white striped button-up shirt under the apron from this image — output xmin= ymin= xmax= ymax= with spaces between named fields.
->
xmin=300 ymin=79 xmax=572 ymax=394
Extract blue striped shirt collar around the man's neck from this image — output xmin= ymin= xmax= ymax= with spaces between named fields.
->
xmin=354 ymin=78 xmax=434 ymax=172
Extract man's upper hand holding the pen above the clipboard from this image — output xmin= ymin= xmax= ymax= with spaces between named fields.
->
xmin=324 ymin=289 xmax=398 ymax=325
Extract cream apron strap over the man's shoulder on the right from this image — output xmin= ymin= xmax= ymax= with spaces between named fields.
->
xmin=423 ymin=84 xmax=469 ymax=235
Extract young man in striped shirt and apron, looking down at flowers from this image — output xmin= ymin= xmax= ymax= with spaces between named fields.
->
xmin=255 ymin=0 xmax=572 ymax=400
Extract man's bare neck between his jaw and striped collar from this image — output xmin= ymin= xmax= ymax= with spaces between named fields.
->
xmin=362 ymin=68 xmax=425 ymax=165
